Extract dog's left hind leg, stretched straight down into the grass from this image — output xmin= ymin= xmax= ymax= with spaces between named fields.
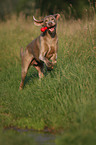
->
xmin=19 ymin=50 xmax=33 ymax=90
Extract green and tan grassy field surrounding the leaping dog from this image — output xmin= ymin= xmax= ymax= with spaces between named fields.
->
xmin=0 ymin=17 xmax=96 ymax=144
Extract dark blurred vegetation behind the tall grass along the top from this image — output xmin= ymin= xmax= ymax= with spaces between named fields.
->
xmin=0 ymin=0 xmax=96 ymax=20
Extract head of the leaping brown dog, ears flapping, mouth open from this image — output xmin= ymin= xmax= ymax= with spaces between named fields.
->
xmin=33 ymin=14 xmax=60 ymax=33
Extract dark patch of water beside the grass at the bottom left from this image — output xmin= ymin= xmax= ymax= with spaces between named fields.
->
xmin=4 ymin=129 xmax=57 ymax=145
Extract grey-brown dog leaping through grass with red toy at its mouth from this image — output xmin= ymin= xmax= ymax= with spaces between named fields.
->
xmin=19 ymin=14 xmax=60 ymax=90
